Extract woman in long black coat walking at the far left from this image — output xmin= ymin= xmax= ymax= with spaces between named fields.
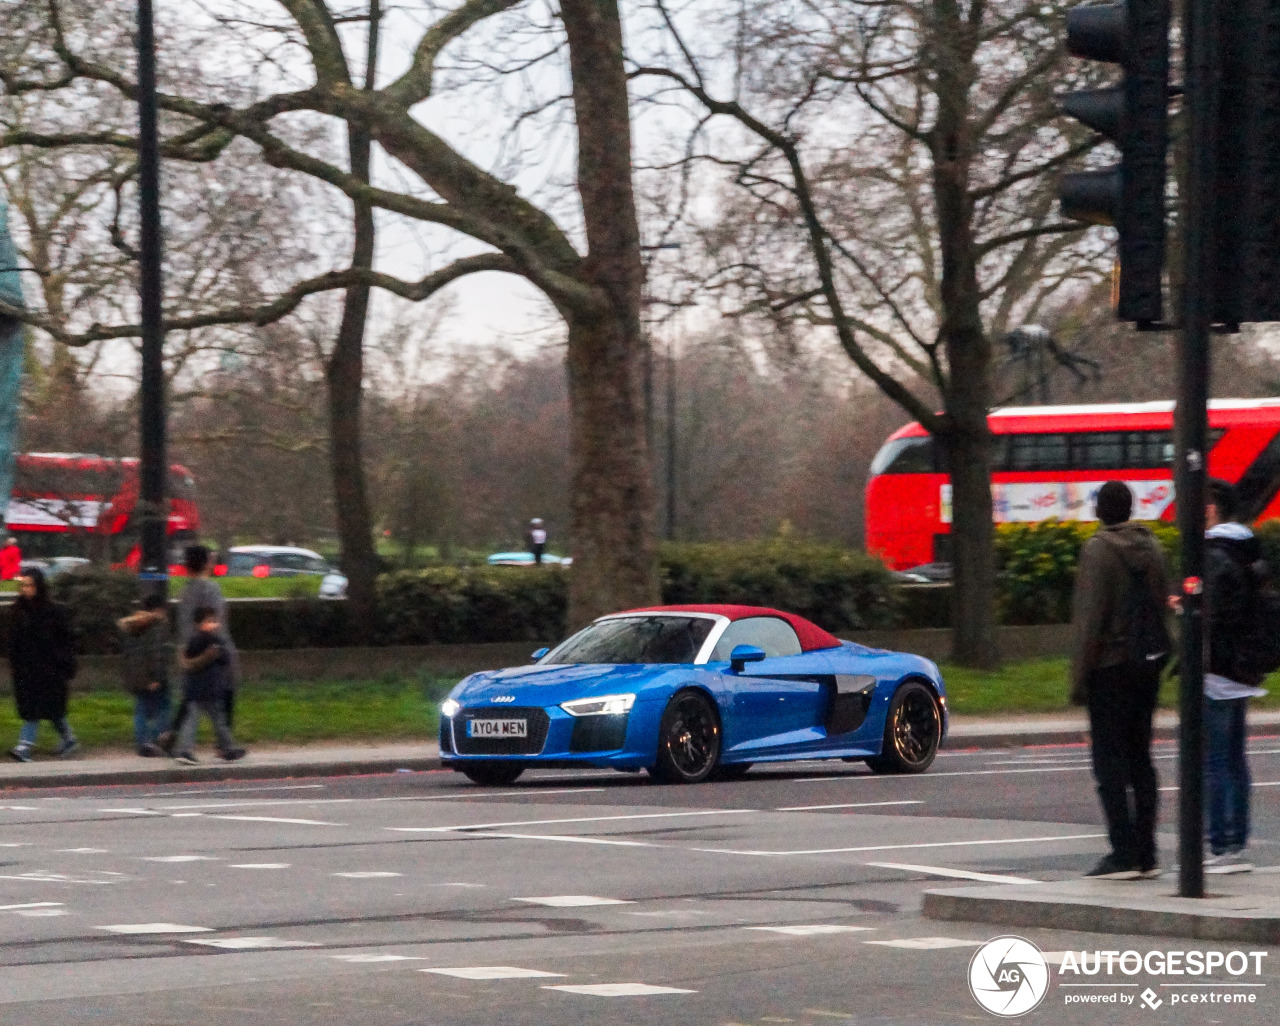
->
xmin=9 ymin=569 xmax=79 ymax=762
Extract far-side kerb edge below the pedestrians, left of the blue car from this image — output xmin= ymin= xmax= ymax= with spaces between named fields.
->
xmin=0 ymin=755 xmax=442 ymax=792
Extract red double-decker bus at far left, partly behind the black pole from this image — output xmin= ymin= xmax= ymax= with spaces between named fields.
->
xmin=5 ymin=453 xmax=200 ymax=565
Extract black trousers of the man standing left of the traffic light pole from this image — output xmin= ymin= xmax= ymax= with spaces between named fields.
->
xmin=1089 ymin=663 xmax=1160 ymax=869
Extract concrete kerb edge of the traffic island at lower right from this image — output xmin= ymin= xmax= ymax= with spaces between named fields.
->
xmin=922 ymin=887 xmax=1280 ymax=944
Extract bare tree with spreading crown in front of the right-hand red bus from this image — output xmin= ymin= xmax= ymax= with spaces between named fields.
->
xmin=632 ymin=0 xmax=1105 ymax=665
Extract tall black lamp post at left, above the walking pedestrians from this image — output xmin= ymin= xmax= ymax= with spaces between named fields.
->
xmin=137 ymin=0 xmax=169 ymax=596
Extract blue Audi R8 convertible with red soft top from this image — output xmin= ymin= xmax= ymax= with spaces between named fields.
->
xmin=440 ymin=605 xmax=947 ymax=784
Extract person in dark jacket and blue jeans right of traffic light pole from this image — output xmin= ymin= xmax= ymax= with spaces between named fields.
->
xmin=1204 ymin=478 xmax=1275 ymax=872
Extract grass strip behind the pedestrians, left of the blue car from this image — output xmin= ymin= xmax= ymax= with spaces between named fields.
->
xmin=0 ymin=675 xmax=457 ymax=748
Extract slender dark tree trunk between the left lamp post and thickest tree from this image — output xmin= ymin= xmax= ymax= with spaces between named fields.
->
xmin=325 ymin=0 xmax=380 ymax=642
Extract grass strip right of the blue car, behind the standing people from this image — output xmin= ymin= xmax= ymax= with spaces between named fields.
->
xmin=942 ymin=658 xmax=1280 ymax=716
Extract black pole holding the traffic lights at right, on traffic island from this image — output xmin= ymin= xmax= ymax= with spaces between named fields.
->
xmin=1175 ymin=0 xmax=1220 ymax=898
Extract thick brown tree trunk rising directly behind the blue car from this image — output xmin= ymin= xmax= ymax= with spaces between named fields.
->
xmin=561 ymin=0 xmax=658 ymax=627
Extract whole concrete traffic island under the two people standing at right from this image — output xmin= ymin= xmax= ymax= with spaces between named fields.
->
xmin=923 ymin=871 xmax=1280 ymax=944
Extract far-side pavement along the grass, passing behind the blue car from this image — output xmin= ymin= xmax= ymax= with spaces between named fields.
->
xmin=0 ymin=710 xmax=1280 ymax=791
